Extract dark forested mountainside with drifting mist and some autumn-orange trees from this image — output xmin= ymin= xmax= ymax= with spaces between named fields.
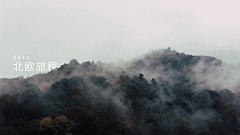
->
xmin=0 ymin=48 xmax=240 ymax=135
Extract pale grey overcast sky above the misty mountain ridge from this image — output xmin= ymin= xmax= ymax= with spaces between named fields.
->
xmin=0 ymin=0 xmax=240 ymax=78
